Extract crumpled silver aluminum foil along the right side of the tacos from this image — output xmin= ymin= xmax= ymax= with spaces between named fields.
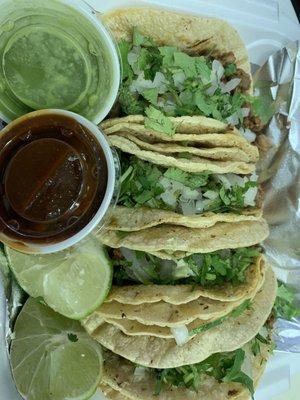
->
xmin=254 ymin=42 xmax=300 ymax=352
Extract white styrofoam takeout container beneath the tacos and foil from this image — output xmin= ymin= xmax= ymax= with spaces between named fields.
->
xmin=0 ymin=0 xmax=300 ymax=400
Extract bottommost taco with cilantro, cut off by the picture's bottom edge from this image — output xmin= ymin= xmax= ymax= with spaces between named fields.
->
xmin=100 ymin=336 xmax=272 ymax=400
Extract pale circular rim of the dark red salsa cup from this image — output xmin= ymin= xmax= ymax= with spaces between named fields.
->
xmin=1 ymin=109 xmax=116 ymax=254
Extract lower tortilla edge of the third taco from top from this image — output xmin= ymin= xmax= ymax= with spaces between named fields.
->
xmin=105 ymin=256 xmax=265 ymax=305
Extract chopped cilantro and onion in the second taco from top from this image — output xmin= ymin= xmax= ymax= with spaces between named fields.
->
xmin=119 ymin=153 xmax=257 ymax=214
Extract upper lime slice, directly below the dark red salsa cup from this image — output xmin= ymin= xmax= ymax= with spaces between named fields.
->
xmin=6 ymin=237 xmax=113 ymax=319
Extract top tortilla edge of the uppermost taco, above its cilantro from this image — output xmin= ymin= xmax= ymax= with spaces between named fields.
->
xmin=100 ymin=7 xmax=251 ymax=83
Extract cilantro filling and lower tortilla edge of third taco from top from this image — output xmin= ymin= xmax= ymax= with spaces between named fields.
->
xmin=106 ymin=247 xmax=265 ymax=305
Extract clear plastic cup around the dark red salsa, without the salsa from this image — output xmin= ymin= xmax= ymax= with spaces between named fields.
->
xmin=0 ymin=109 xmax=120 ymax=254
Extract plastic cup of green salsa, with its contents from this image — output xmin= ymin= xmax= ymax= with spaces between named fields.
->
xmin=0 ymin=0 xmax=120 ymax=123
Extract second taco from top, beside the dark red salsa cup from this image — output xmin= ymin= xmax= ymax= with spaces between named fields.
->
xmin=99 ymin=117 xmax=261 ymax=231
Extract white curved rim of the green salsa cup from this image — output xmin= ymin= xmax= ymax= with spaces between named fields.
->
xmin=0 ymin=0 xmax=121 ymax=124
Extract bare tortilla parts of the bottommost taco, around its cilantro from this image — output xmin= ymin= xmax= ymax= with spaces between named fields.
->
xmin=101 ymin=344 xmax=270 ymax=400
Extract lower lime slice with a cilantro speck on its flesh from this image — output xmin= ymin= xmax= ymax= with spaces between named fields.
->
xmin=11 ymin=298 xmax=103 ymax=400
